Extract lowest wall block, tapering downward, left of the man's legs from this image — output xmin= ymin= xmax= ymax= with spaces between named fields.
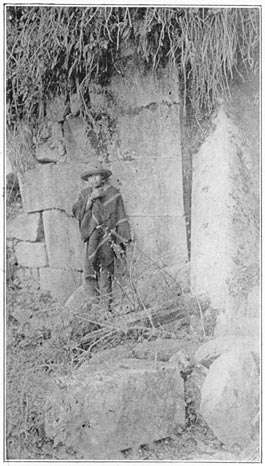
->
xmin=40 ymin=267 xmax=82 ymax=304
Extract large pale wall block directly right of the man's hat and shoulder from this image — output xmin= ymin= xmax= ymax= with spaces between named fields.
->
xmin=111 ymin=157 xmax=184 ymax=216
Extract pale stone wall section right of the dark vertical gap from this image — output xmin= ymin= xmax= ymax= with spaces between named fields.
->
xmin=191 ymin=75 xmax=260 ymax=336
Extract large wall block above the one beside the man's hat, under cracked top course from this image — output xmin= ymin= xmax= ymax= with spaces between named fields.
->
xmin=114 ymin=104 xmax=181 ymax=160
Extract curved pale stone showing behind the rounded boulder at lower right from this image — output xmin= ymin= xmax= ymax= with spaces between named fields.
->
xmin=194 ymin=335 xmax=260 ymax=368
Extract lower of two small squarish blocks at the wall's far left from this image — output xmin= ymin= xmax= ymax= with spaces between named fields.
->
xmin=15 ymin=241 xmax=48 ymax=268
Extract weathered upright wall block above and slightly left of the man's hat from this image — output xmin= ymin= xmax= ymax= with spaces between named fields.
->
xmin=64 ymin=116 xmax=97 ymax=162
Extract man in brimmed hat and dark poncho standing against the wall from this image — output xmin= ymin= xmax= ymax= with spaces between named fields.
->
xmin=72 ymin=163 xmax=131 ymax=311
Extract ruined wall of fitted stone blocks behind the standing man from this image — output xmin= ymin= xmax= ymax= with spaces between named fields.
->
xmin=7 ymin=66 xmax=187 ymax=303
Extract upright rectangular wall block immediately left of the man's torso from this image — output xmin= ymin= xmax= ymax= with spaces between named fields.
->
xmin=43 ymin=210 xmax=83 ymax=270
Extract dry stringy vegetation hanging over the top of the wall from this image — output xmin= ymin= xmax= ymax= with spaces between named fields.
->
xmin=6 ymin=6 xmax=259 ymax=125
